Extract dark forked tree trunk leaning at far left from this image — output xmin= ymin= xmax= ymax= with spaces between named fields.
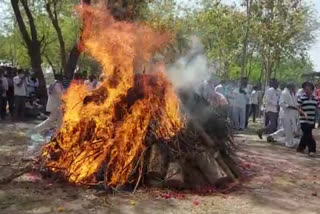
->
xmin=11 ymin=0 xmax=47 ymax=99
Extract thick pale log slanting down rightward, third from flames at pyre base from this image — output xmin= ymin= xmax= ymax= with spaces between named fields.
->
xmin=195 ymin=152 xmax=228 ymax=185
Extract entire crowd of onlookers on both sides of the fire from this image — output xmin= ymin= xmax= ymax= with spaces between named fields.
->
xmin=0 ymin=64 xmax=320 ymax=156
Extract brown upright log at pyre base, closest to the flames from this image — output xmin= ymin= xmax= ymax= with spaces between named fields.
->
xmin=147 ymin=143 xmax=169 ymax=180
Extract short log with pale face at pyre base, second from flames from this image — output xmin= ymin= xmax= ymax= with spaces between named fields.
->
xmin=165 ymin=161 xmax=185 ymax=189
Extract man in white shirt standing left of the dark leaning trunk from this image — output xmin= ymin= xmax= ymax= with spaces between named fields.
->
xmin=13 ymin=69 xmax=27 ymax=120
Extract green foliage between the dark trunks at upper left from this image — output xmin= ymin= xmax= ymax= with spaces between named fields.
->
xmin=0 ymin=0 xmax=79 ymax=70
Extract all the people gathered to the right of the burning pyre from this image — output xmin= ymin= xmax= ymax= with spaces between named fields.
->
xmin=202 ymin=78 xmax=320 ymax=156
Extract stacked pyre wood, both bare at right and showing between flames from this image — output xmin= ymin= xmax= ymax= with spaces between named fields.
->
xmin=42 ymin=74 xmax=241 ymax=189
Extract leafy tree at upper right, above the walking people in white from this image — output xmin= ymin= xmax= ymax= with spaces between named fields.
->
xmin=252 ymin=0 xmax=318 ymax=84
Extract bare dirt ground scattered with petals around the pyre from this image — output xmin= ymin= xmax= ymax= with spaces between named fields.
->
xmin=0 ymin=122 xmax=320 ymax=214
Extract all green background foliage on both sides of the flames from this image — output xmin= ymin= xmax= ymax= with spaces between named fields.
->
xmin=0 ymin=0 xmax=319 ymax=86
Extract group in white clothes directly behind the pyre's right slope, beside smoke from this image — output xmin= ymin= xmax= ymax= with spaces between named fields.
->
xmin=202 ymin=78 xmax=263 ymax=131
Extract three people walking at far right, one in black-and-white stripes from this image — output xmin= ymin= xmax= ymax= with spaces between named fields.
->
xmin=257 ymin=81 xmax=320 ymax=157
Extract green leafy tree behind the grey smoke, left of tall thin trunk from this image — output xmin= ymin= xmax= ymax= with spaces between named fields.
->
xmin=195 ymin=2 xmax=245 ymax=78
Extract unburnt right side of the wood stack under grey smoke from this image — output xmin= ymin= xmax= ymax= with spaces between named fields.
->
xmin=144 ymin=87 xmax=241 ymax=189
